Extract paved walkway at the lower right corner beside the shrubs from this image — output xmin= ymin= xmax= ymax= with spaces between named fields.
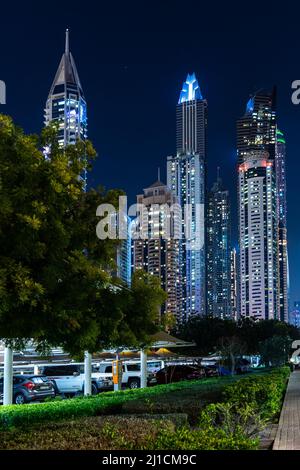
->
xmin=273 ymin=370 xmax=300 ymax=450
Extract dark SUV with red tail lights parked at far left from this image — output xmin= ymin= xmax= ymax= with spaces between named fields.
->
xmin=0 ymin=375 xmax=55 ymax=405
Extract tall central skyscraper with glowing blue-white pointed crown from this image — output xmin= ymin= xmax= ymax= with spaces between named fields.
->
xmin=167 ymin=73 xmax=207 ymax=321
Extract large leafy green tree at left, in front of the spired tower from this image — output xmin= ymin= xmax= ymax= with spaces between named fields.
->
xmin=0 ymin=115 xmax=162 ymax=355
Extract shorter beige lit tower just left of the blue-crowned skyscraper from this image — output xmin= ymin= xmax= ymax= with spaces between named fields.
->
xmin=133 ymin=180 xmax=181 ymax=322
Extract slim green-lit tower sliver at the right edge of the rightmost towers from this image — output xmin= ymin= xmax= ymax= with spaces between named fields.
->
xmin=275 ymin=129 xmax=289 ymax=322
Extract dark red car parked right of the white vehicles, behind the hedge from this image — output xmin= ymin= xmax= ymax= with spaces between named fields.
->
xmin=156 ymin=364 xmax=205 ymax=384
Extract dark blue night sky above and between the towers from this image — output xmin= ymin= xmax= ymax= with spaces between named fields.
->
xmin=0 ymin=0 xmax=300 ymax=302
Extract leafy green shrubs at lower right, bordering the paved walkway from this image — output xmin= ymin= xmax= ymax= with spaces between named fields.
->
xmin=148 ymin=367 xmax=290 ymax=450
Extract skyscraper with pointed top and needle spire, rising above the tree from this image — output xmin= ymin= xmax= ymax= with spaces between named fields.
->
xmin=45 ymin=30 xmax=87 ymax=184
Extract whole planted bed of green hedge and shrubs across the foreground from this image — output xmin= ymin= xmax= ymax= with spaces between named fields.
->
xmin=0 ymin=368 xmax=289 ymax=450
